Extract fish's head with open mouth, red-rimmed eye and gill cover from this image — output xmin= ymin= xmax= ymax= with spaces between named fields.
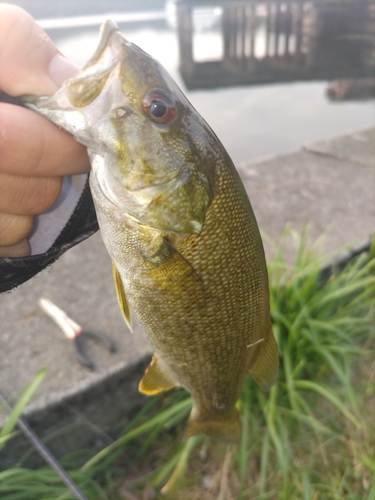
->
xmin=24 ymin=21 xmax=222 ymax=235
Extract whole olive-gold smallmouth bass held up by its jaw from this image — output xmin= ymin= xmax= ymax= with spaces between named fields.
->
xmin=24 ymin=21 xmax=278 ymax=443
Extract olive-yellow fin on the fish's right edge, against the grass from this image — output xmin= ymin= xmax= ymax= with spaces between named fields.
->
xmin=249 ymin=322 xmax=279 ymax=391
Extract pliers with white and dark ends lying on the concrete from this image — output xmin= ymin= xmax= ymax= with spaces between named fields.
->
xmin=38 ymin=298 xmax=117 ymax=370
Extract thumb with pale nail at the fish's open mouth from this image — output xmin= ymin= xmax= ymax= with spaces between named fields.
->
xmin=0 ymin=4 xmax=78 ymax=96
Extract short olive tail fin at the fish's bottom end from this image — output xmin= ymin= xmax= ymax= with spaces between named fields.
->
xmin=184 ymin=408 xmax=241 ymax=444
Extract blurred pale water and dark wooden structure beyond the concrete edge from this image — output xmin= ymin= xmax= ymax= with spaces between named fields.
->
xmin=3 ymin=0 xmax=375 ymax=166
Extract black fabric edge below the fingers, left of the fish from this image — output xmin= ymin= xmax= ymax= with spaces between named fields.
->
xmin=0 ymin=180 xmax=99 ymax=292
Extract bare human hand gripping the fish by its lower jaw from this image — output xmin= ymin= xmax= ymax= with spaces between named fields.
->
xmin=0 ymin=4 xmax=90 ymax=257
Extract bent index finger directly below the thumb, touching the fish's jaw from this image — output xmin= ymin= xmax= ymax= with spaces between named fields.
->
xmin=0 ymin=103 xmax=90 ymax=176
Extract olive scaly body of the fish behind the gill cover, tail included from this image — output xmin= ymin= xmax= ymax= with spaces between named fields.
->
xmin=93 ymin=146 xmax=277 ymax=442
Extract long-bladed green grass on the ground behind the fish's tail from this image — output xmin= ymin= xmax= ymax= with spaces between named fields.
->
xmin=0 ymin=231 xmax=375 ymax=500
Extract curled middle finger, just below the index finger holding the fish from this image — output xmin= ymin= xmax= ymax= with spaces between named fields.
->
xmin=0 ymin=173 xmax=62 ymax=215
